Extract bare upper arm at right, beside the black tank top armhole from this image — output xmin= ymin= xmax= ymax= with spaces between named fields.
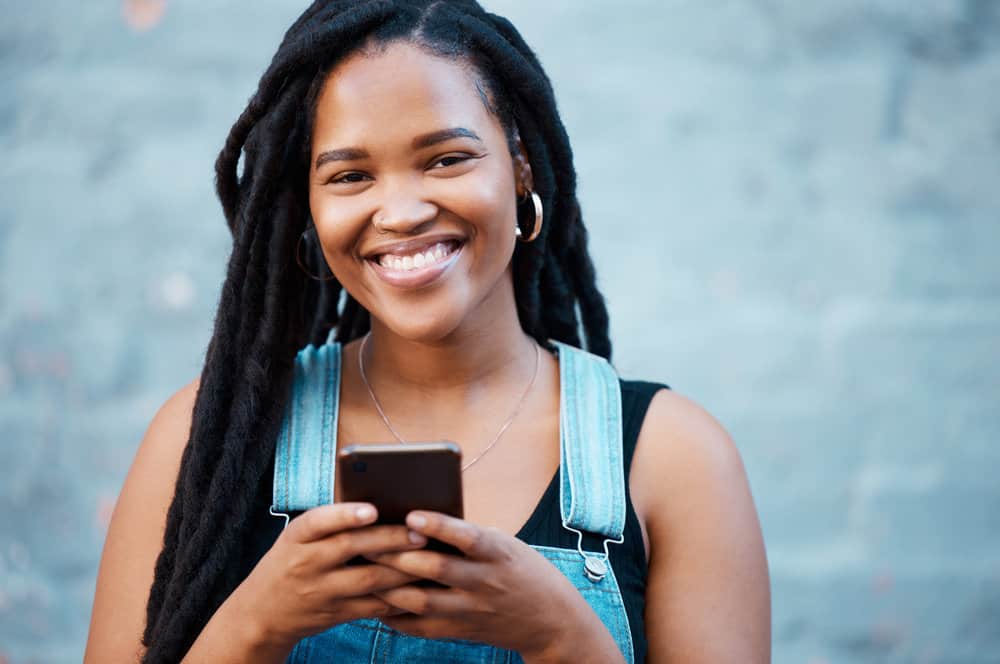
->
xmin=630 ymin=390 xmax=771 ymax=664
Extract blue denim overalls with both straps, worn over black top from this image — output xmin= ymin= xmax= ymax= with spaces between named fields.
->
xmin=271 ymin=340 xmax=634 ymax=664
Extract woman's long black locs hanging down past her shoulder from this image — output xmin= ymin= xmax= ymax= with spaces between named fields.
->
xmin=143 ymin=0 xmax=611 ymax=664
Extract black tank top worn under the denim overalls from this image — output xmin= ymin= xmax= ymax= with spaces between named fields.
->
xmin=239 ymin=380 xmax=669 ymax=662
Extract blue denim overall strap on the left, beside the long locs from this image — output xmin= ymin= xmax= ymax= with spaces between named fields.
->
xmin=271 ymin=341 xmax=340 ymax=512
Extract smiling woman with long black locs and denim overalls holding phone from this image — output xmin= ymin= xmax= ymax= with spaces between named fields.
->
xmin=86 ymin=0 xmax=770 ymax=663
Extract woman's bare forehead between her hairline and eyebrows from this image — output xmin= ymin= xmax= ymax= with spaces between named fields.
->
xmin=313 ymin=42 xmax=502 ymax=146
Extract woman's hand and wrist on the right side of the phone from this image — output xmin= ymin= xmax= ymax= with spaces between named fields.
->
xmin=370 ymin=511 xmax=621 ymax=662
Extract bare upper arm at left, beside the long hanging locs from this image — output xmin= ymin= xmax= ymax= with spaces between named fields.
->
xmin=84 ymin=380 xmax=198 ymax=664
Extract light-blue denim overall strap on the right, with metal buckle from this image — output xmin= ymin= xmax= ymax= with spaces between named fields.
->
xmin=553 ymin=341 xmax=626 ymax=564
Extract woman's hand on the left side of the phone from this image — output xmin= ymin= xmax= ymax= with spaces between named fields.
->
xmin=233 ymin=503 xmax=427 ymax=648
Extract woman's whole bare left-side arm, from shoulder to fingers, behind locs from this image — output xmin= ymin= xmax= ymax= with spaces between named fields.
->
xmin=84 ymin=382 xmax=425 ymax=664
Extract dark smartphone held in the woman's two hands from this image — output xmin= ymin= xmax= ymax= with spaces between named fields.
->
xmin=337 ymin=441 xmax=463 ymax=563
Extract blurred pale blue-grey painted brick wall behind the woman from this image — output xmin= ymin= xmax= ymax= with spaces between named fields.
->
xmin=0 ymin=0 xmax=1000 ymax=664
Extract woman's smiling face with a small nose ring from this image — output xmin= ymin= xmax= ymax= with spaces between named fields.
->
xmin=309 ymin=42 xmax=530 ymax=341
